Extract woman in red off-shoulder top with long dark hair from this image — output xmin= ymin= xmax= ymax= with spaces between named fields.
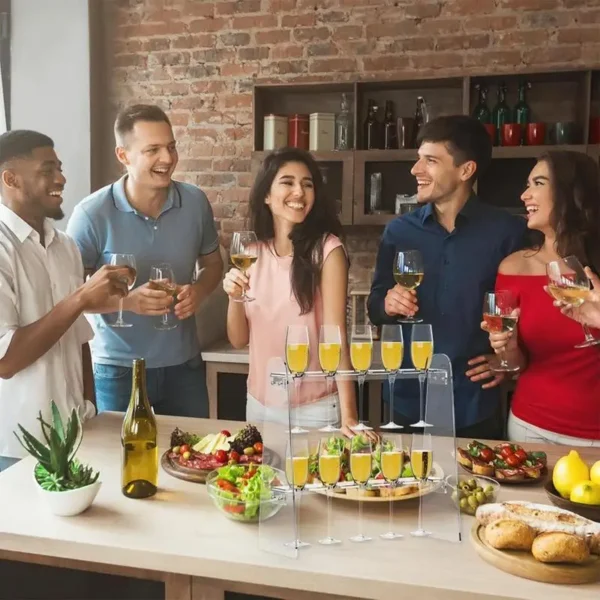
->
xmin=482 ymin=151 xmax=600 ymax=446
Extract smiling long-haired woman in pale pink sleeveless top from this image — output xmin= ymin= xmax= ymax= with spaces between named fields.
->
xmin=223 ymin=148 xmax=357 ymax=435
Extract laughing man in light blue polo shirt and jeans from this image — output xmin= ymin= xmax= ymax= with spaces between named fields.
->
xmin=67 ymin=105 xmax=223 ymax=417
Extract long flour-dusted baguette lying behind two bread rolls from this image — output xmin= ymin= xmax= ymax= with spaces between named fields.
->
xmin=475 ymin=502 xmax=600 ymax=554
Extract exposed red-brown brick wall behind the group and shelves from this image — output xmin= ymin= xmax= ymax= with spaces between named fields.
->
xmin=97 ymin=0 xmax=600 ymax=280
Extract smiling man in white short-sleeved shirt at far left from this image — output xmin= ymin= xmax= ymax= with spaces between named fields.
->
xmin=0 ymin=130 xmax=129 ymax=471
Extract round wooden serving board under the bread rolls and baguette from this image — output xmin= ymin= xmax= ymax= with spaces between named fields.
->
xmin=471 ymin=522 xmax=600 ymax=585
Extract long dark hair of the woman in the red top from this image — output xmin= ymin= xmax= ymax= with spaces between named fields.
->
xmin=538 ymin=150 xmax=600 ymax=272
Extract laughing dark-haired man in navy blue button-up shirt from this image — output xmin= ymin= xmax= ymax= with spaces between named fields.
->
xmin=368 ymin=115 xmax=526 ymax=439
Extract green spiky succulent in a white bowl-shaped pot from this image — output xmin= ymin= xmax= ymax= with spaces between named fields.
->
xmin=15 ymin=401 xmax=101 ymax=517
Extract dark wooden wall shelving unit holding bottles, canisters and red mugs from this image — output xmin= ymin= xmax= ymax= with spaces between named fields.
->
xmin=252 ymin=70 xmax=600 ymax=226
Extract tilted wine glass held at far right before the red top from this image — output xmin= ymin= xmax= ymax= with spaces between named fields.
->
xmin=546 ymin=256 xmax=600 ymax=348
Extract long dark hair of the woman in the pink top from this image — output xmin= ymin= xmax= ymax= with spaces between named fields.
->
xmin=250 ymin=148 xmax=342 ymax=315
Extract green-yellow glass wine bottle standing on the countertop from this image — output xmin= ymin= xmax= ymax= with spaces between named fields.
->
xmin=121 ymin=358 xmax=158 ymax=498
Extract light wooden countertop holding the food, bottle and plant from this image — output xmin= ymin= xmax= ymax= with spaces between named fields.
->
xmin=0 ymin=413 xmax=600 ymax=600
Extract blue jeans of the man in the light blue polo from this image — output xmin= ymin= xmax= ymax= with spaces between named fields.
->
xmin=94 ymin=355 xmax=208 ymax=418
